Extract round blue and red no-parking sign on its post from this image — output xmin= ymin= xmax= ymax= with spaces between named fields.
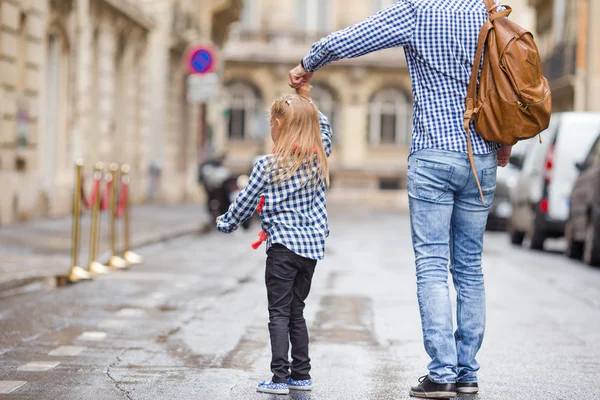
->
xmin=185 ymin=45 xmax=219 ymax=161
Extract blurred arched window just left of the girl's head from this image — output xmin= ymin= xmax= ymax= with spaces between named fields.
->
xmin=226 ymin=82 xmax=262 ymax=140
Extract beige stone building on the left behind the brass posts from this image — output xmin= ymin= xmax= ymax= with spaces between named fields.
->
xmin=0 ymin=0 xmax=241 ymax=225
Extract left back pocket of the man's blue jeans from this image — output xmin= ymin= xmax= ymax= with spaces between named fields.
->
xmin=413 ymin=159 xmax=454 ymax=201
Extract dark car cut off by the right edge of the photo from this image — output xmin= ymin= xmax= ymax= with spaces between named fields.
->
xmin=565 ymin=136 xmax=600 ymax=266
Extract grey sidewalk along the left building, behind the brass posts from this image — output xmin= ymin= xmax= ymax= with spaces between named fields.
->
xmin=0 ymin=204 xmax=208 ymax=291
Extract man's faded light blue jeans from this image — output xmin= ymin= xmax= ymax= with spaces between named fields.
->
xmin=408 ymin=150 xmax=498 ymax=384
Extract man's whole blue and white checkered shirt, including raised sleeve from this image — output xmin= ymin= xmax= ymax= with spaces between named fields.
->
xmin=302 ymin=0 xmax=499 ymax=154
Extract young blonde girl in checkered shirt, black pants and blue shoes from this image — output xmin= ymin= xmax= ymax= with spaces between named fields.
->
xmin=217 ymin=85 xmax=331 ymax=394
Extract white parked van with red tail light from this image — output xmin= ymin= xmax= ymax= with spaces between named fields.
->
xmin=508 ymin=113 xmax=600 ymax=250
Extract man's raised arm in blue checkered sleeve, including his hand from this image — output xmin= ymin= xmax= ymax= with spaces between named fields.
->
xmin=290 ymin=0 xmax=416 ymax=87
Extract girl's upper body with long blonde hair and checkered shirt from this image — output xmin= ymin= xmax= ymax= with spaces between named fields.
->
xmin=218 ymin=95 xmax=332 ymax=260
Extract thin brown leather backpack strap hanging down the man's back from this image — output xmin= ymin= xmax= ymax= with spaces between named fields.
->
xmin=464 ymin=16 xmax=494 ymax=206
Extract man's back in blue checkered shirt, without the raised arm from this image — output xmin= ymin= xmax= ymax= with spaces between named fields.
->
xmin=404 ymin=0 xmax=497 ymax=154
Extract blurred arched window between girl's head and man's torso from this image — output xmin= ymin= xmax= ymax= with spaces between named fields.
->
xmin=369 ymin=89 xmax=412 ymax=146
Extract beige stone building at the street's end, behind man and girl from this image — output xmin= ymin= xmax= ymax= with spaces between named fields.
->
xmin=217 ymin=0 xmax=533 ymax=191
